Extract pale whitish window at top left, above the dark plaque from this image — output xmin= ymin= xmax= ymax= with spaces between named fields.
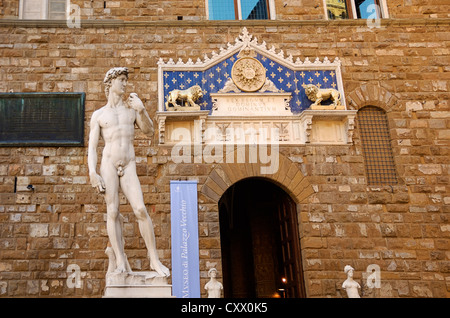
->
xmin=19 ymin=0 xmax=70 ymax=20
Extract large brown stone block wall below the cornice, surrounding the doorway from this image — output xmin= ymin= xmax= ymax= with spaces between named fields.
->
xmin=0 ymin=9 xmax=450 ymax=297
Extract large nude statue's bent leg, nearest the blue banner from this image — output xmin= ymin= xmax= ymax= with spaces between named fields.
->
xmin=120 ymin=161 xmax=170 ymax=276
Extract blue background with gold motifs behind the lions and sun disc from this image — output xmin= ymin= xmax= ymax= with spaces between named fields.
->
xmin=163 ymin=53 xmax=339 ymax=114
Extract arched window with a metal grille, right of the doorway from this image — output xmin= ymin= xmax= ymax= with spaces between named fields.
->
xmin=356 ymin=106 xmax=398 ymax=185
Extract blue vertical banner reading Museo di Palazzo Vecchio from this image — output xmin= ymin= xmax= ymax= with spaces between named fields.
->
xmin=170 ymin=180 xmax=200 ymax=298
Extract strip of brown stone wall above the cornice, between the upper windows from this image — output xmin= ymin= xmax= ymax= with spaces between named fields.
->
xmin=0 ymin=0 xmax=450 ymax=21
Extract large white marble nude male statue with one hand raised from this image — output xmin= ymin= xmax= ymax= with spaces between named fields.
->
xmin=88 ymin=67 xmax=170 ymax=276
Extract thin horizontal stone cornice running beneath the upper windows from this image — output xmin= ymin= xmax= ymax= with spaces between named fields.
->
xmin=0 ymin=18 xmax=450 ymax=28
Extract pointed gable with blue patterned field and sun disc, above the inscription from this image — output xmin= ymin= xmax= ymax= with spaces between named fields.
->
xmin=158 ymin=28 xmax=345 ymax=115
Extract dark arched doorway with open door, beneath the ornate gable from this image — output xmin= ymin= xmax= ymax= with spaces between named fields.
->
xmin=219 ymin=177 xmax=305 ymax=298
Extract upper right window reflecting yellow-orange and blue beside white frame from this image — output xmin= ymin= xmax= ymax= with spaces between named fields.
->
xmin=325 ymin=0 xmax=388 ymax=20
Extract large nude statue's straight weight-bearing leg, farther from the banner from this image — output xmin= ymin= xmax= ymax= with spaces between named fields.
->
xmin=100 ymin=163 xmax=127 ymax=272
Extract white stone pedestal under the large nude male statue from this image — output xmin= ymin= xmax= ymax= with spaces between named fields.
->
xmin=103 ymin=271 xmax=173 ymax=298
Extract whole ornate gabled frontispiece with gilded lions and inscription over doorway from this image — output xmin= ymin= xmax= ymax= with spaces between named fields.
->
xmin=156 ymin=28 xmax=355 ymax=144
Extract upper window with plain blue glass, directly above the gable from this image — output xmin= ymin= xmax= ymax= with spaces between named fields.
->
xmin=206 ymin=0 xmax=274 ymax=20
